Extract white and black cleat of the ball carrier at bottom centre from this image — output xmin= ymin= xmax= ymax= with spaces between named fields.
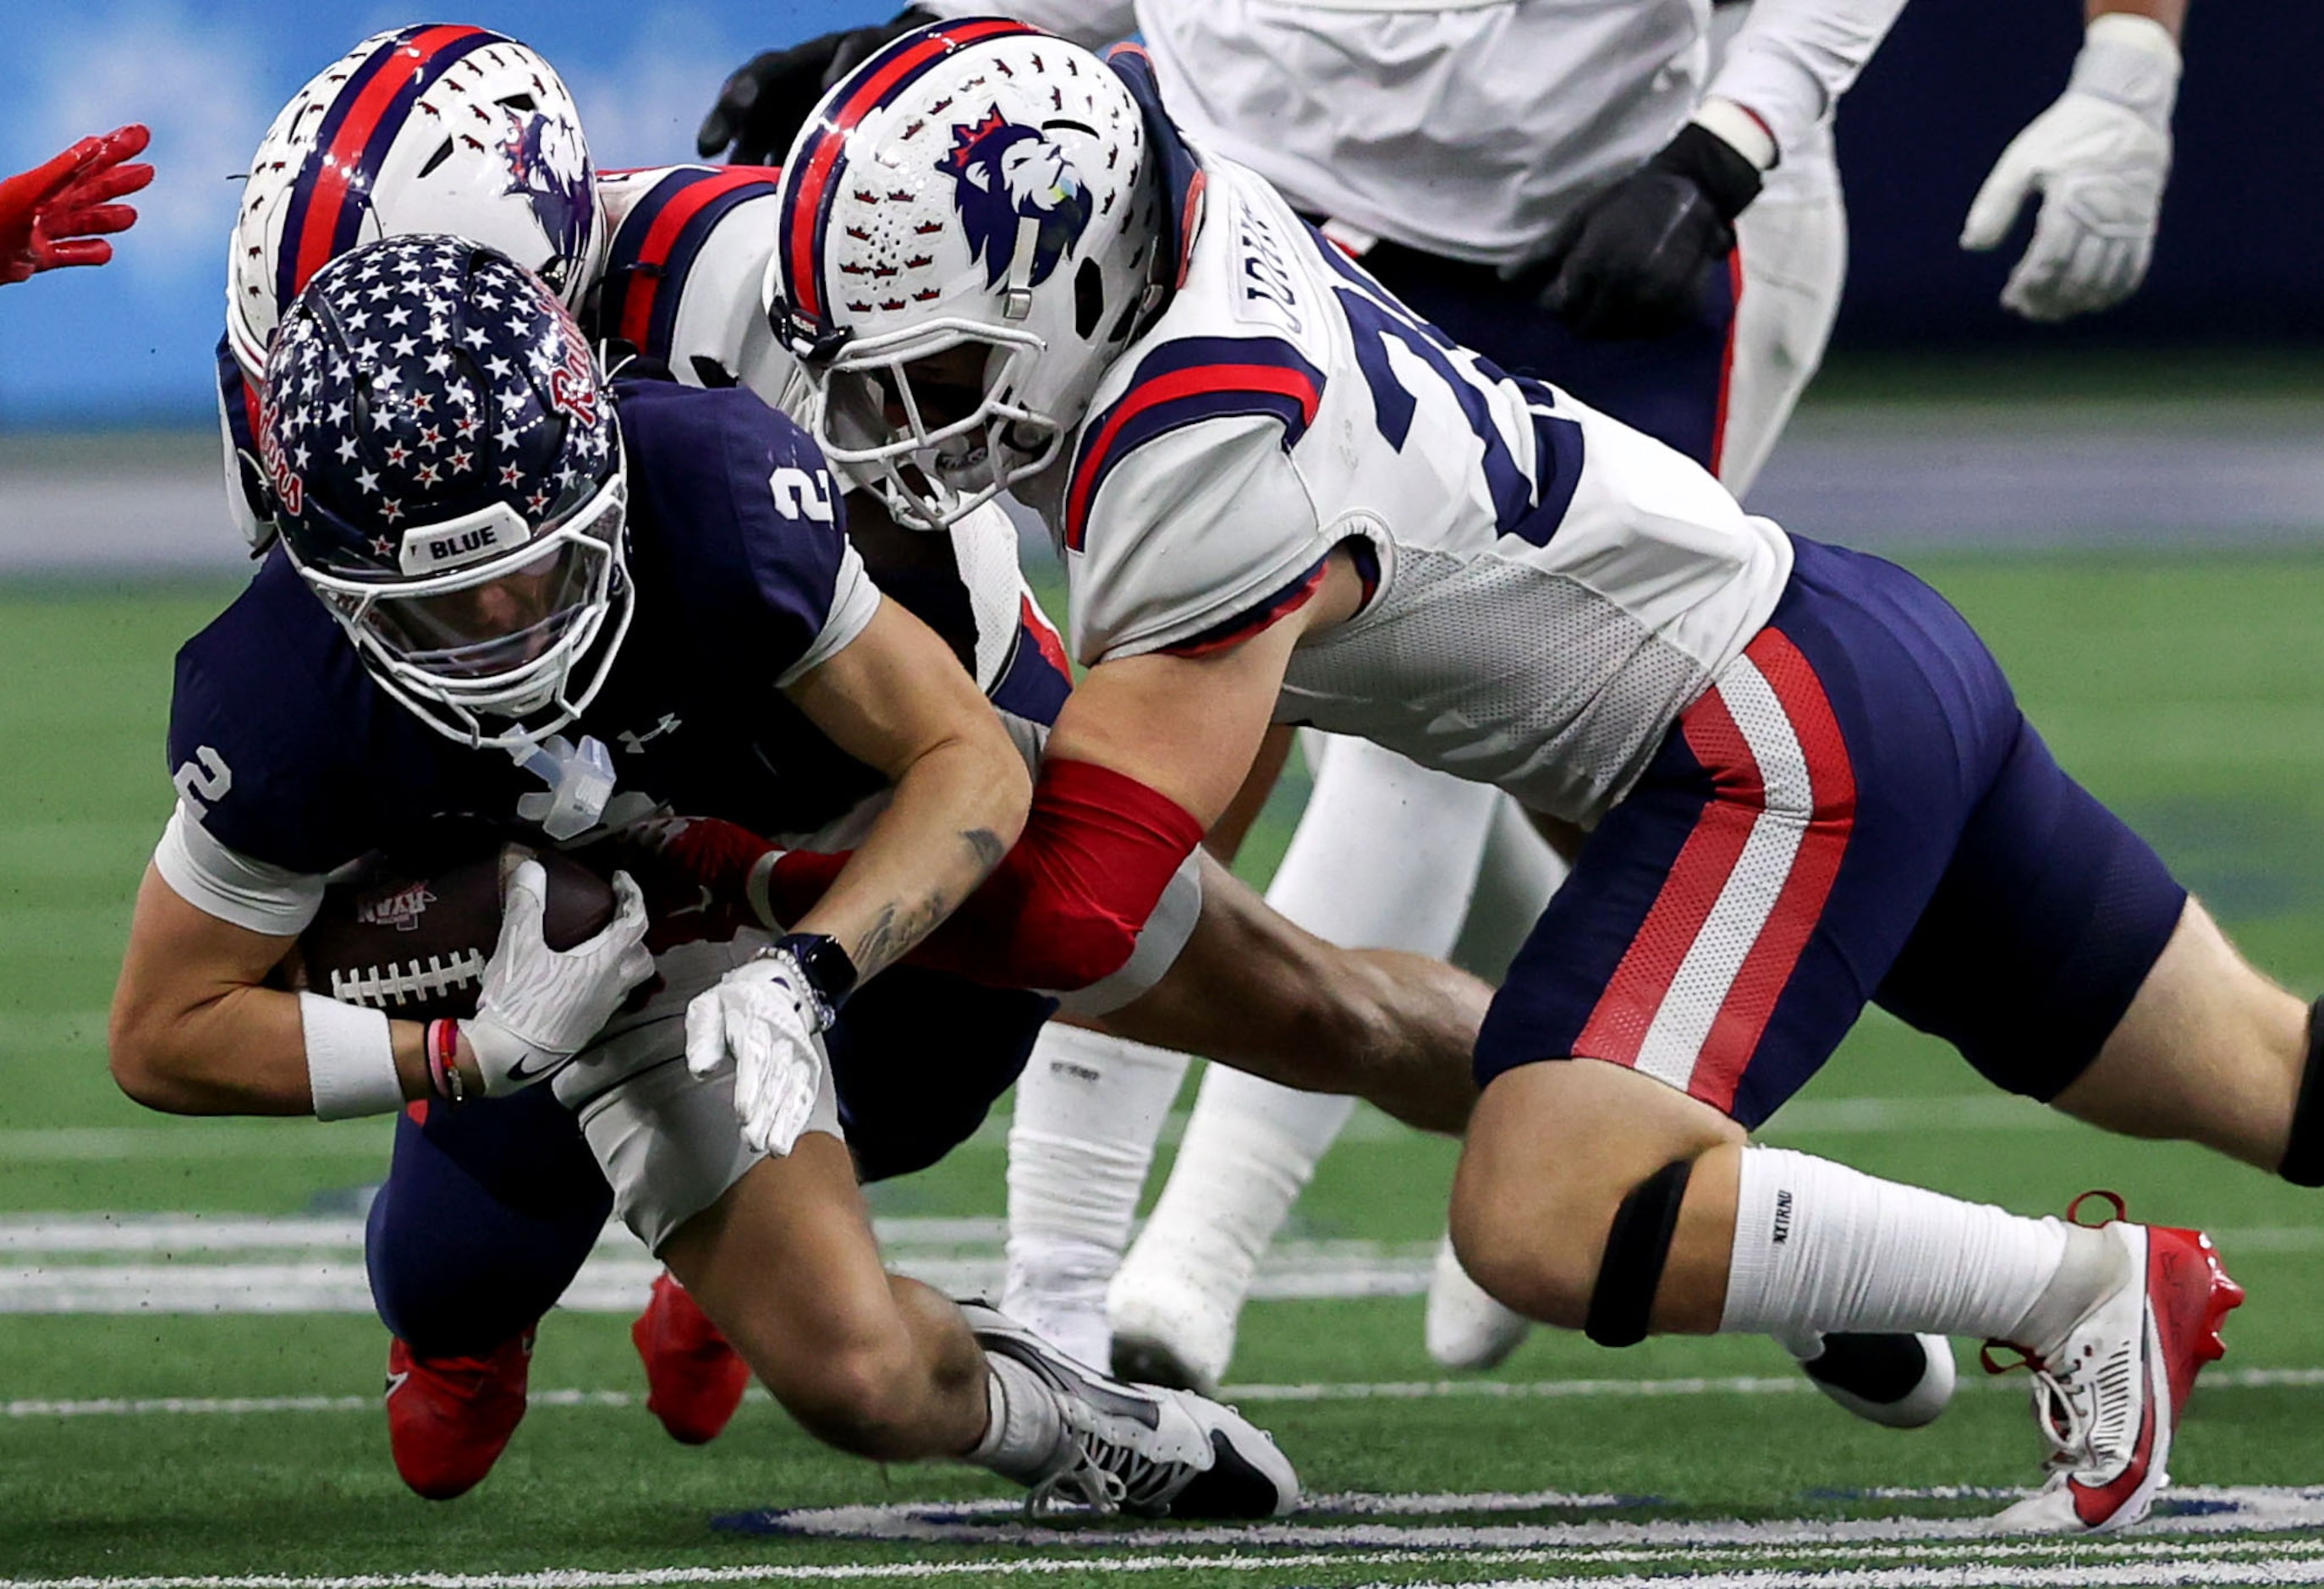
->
xmin=960 ymin=1303 xmax=1299 ymax=1520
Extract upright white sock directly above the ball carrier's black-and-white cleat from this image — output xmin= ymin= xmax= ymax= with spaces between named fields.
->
xmin=1002 ymin=1022 xmax=1188 ymax=1371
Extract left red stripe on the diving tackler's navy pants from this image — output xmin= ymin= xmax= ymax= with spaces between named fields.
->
xmin=1574 ymin=685 xmax=1766 ymax=1064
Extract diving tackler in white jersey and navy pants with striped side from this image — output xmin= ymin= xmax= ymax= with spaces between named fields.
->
xmin=769 ymin=21 xmax=2287 ymax=1531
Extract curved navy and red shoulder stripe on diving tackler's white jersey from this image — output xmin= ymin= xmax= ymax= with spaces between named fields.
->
xmin=1064 ymin=337 xmax=1322 ymax=551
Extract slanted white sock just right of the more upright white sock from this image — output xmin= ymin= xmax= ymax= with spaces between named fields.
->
xmin=1123 ymin=1064 xmax=1355 ymax=1317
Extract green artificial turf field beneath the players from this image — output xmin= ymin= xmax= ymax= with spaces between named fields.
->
xmin=0 ymin=553 xmax=2324 ymax=1589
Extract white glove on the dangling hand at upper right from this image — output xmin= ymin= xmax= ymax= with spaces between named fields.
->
xmin=1961 ymin=12 xmax=2180 ymax=321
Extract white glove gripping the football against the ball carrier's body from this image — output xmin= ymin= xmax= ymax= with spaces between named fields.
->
xmin=460 ymin=860 xmax=653 ymax=1099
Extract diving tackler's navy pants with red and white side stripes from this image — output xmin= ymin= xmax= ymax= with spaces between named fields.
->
xmin=1475 ymin=536 xmax=2187 ymax=1127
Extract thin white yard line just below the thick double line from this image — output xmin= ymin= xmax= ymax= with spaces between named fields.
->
xmin=14 ymin=1368 xmax=2324 ymax=1421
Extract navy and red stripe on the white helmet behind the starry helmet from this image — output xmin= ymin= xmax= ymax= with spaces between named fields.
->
xmin=274 ymin=23 xmax=507 ymax=306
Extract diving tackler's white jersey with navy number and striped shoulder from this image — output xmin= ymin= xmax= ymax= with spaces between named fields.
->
xmin=1034 ymin=158 xmax=1792 ymax=825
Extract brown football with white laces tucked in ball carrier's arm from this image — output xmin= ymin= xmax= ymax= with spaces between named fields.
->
xmin=298 ymin=844 xmax=613 ymax=1020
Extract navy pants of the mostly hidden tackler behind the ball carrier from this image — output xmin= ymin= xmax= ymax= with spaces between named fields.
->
xmin=365 ymin=966 xmax=1055 ymax=1356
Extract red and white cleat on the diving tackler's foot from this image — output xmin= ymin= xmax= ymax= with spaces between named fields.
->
xmin=1987 ymin=1192 xmax=2243 ymax=1533
